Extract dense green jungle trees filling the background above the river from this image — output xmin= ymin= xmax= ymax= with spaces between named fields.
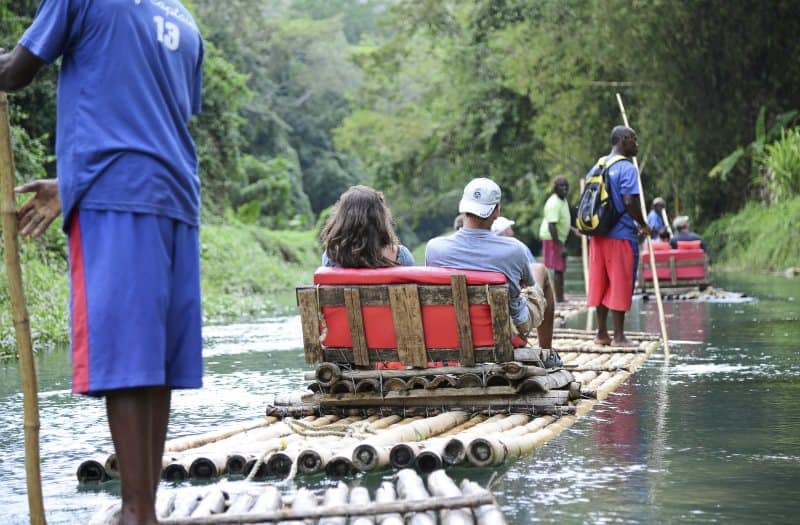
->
xmin=0 ymin=0 xmax=800 ymax=354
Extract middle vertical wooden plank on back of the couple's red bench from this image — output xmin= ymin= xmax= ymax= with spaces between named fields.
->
xmin=388 ymin=284 xmax=428 ymax=367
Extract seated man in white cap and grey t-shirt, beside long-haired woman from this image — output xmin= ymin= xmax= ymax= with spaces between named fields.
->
xmin=425 ymin=178 xmax=561 ymax=367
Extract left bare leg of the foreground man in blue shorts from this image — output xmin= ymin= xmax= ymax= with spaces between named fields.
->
xmin=106 ymin=387 xmax=162 ymax=525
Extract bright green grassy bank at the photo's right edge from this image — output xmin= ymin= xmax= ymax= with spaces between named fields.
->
xmin=703 ymin=197 xmax=800 ymax=272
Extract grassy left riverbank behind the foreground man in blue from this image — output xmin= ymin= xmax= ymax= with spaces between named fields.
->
xmin=0 ymin=219 xmax=319 ymax=358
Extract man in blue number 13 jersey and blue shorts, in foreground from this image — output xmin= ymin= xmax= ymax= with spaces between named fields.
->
xmin=0 ymin=0 xmax=203 ymax=524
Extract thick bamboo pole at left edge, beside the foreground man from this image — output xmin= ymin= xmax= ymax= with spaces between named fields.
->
xmin=0 ymin=91 xmax=46 ymax=525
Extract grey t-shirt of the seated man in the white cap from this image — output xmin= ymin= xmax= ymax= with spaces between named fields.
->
xmin=425 ymin=228 xmax=534 ymax=324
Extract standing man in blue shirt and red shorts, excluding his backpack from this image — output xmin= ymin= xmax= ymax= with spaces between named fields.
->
xmin=586 ymin=126 xmax=651 ymax=346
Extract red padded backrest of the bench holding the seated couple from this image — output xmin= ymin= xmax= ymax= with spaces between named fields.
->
xmin=314 ymin=266 xmax=506 ymax=350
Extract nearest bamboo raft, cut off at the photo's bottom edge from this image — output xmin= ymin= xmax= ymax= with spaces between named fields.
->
xmin=89 ymin=469 xmax=506 ymax=525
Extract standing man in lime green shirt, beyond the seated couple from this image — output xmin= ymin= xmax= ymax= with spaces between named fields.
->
xmin=539 ymin=175 xmax=577 ymax=303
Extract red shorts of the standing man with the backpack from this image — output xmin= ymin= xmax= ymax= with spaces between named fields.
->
xmin=586 ymin=237 xmax=636 ymax=312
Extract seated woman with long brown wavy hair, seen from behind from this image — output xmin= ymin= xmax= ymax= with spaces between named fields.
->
xmin=320 ymin=186 xmax=414 ymax=268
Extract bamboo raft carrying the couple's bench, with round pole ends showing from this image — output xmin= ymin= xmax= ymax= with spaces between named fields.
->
xmin=77 ymin=330 xmax=660 ymax=484
